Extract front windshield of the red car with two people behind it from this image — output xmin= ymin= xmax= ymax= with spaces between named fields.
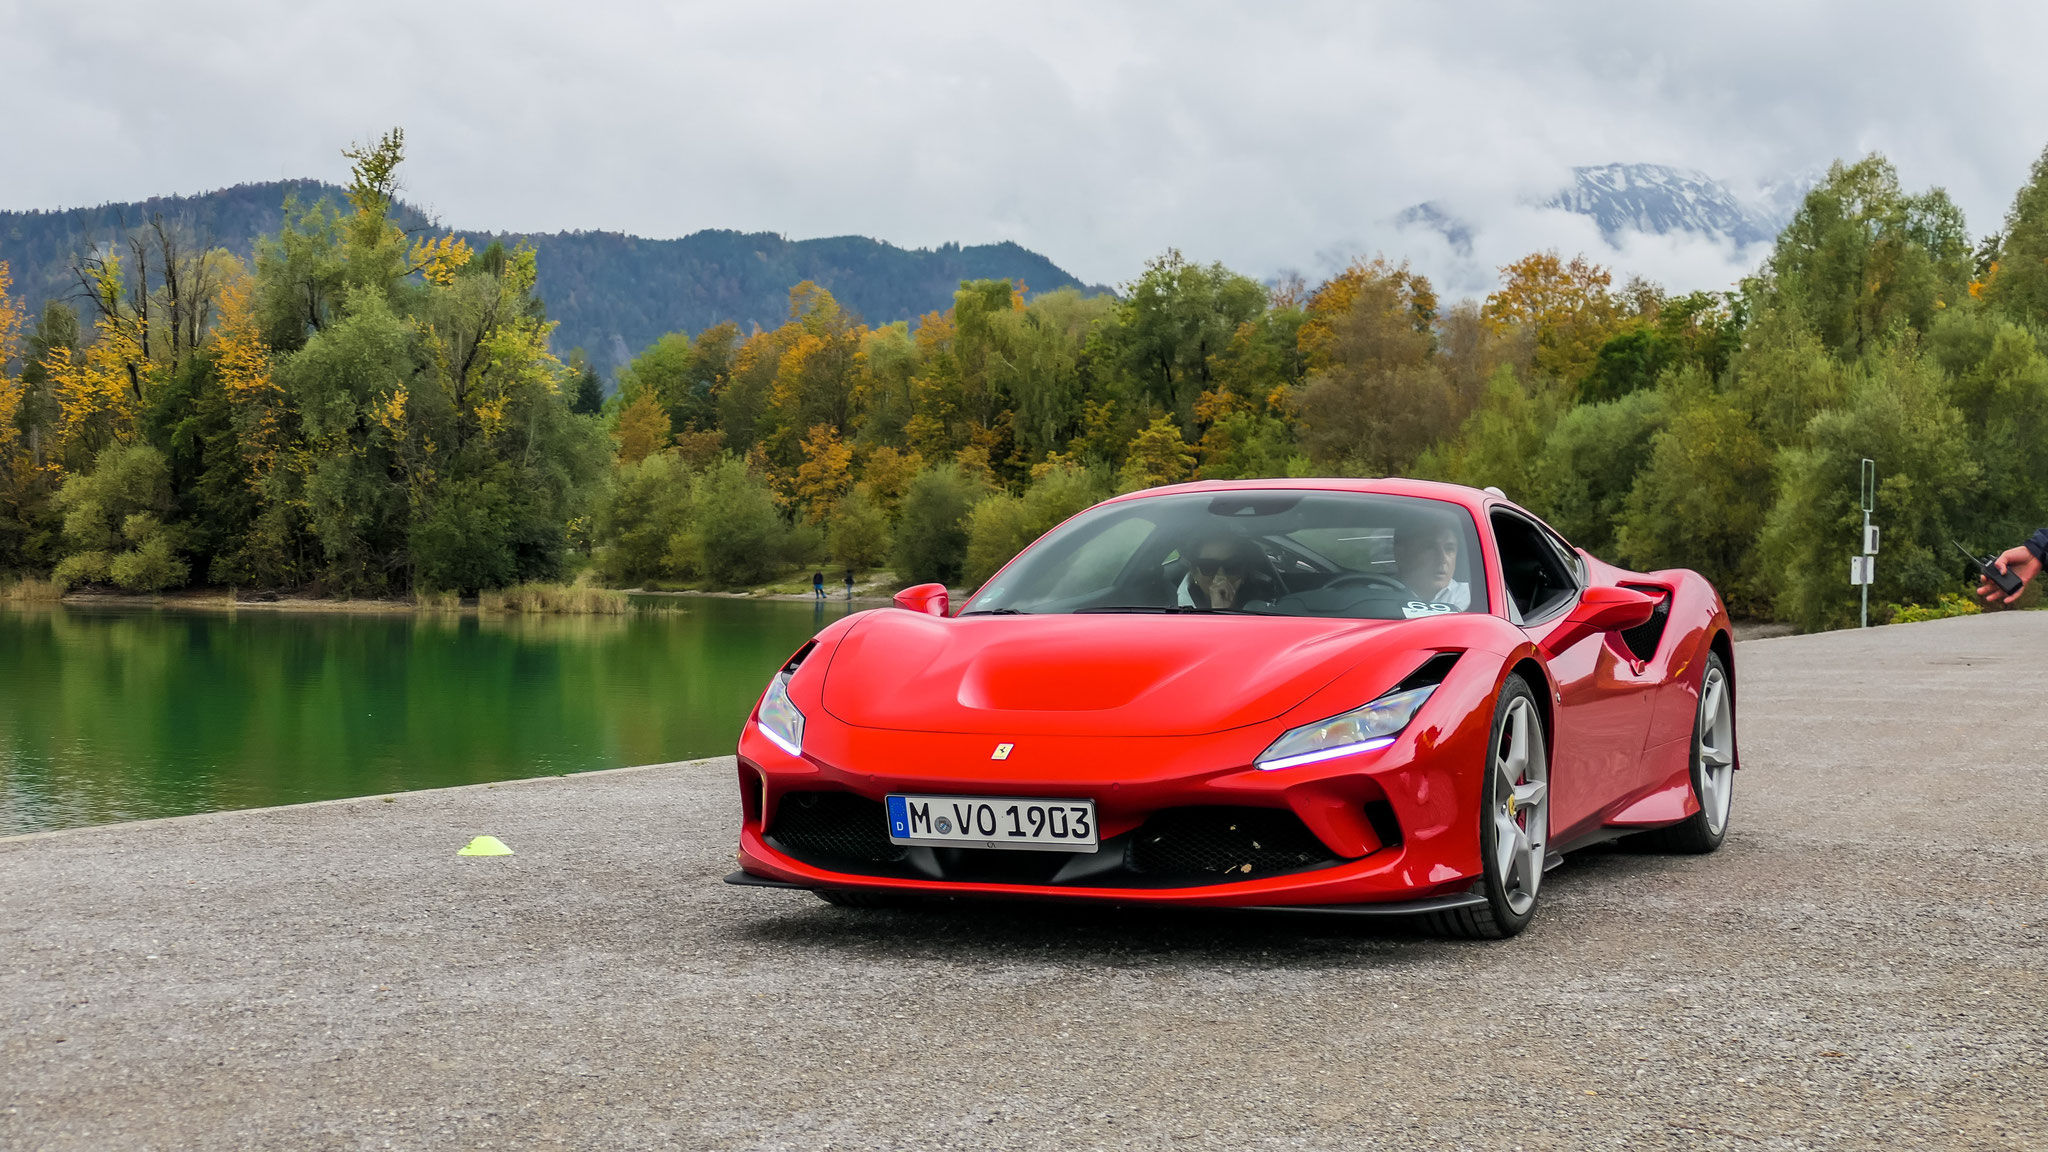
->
xmin=961 ymin=490 xmax=1487 ymax=619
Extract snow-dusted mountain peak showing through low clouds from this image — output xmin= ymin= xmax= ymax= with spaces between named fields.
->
xmin=1395 ymin=164 xmax=1817 ymax=256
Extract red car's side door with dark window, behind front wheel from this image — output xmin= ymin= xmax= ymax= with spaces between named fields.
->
xmin=1489 ymin=506 xmax=1655 ymax=842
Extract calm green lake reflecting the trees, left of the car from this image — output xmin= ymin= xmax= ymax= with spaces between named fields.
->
xmin=0 ymin=596 xmax=858 ymax=836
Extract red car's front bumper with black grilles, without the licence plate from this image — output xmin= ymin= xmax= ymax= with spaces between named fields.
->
xmin=739 ymin=668 xmax=1491 ymax=910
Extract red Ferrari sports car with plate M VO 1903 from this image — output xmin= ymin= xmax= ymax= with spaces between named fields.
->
xmin=729 ymin=480 xmax=1737 ymax=937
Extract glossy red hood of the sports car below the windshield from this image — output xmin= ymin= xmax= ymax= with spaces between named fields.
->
xmin=823 ymin=611 xmax=1399 ymax=736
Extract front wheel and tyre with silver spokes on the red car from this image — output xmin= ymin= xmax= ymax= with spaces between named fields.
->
xmin=1432 ymin=676 xmax=1550 ymax=941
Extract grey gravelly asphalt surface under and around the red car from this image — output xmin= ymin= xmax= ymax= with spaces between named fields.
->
xmin=0 ymin=613 xmax=2048 ymax=1150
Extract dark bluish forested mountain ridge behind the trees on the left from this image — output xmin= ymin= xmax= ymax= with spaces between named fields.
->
xmin=0 ymin=180 xmax=1100 ymax=371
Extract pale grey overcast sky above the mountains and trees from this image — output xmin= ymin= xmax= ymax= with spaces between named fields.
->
xmin=0 ymin=0 xmax=2048 ymax=287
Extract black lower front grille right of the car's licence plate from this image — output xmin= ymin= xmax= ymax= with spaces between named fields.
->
xmin=1130 ymin=808 xmax=1337 ymax=883
